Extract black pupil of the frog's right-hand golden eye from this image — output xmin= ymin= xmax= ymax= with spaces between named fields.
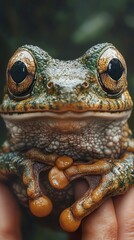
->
xmin=107 ymin=58 xmax=124 ymax=81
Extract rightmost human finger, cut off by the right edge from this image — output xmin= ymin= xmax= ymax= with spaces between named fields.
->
xmin=114 ymin=187 xmax=134 ymax=240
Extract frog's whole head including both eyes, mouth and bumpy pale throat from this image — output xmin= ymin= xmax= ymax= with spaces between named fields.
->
xmin=0 ymin=43 xmax=133 ymax=158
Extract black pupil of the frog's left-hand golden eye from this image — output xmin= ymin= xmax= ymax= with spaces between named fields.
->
xmin=9 ymin=61 xmax=28 ymax=84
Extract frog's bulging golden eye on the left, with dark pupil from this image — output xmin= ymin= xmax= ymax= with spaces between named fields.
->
xmin=7 ymin=49 xmax=36 ymax=98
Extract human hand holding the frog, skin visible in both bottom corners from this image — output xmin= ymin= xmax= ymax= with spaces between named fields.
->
xmin=0 ymin=181 xmax=134 ymax=240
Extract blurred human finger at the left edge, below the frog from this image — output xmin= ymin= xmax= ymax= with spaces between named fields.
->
xmin=0 ymin=183 xmax=21 ymax=240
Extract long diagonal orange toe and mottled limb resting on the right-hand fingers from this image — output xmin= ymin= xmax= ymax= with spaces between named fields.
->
xmin=60 ymin=156 xmax=134 ymax=232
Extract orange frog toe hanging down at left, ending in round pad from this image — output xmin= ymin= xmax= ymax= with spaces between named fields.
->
xmin=23 ymin=162 xmax=53 ymax=217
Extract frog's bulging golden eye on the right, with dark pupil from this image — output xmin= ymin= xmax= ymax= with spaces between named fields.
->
xmin=98 ymin=47 xmax=127 ymax=96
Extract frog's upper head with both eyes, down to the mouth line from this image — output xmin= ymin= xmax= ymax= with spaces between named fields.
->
xmin=0 ymin=43 xmax=133 ymax=118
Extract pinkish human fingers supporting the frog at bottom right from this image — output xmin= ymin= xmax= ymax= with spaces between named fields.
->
xmin=70 ymin=182 xmax=134 ymax=240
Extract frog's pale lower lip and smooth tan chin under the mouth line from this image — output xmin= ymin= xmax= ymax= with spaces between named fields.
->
xmin=2 ymin=110 xmax=131 ymax=134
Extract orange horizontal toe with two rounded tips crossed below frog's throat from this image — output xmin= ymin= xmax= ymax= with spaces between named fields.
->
xmin=48 ymin=156 xmax=112 ymax=189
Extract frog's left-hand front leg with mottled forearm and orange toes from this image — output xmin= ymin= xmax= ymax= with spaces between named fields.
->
xmin=0 ymin=149 xmax=56 ymax=217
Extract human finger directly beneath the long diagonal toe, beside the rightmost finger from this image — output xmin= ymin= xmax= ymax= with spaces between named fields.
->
xmin=82 ymin=199 xmax=117 ymax=240
